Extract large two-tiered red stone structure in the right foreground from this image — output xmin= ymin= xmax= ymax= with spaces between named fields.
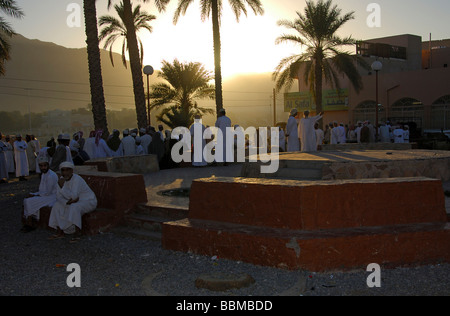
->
xmin=162 ymin=178 xmax=450 ymax=271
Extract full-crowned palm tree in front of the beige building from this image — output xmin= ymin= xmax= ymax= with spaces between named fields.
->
xmin=273 ymin=0 xmax=367 ymax=117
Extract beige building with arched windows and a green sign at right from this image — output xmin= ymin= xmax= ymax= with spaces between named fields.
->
xmin=285 ymin=35 xmax=450 ymax=131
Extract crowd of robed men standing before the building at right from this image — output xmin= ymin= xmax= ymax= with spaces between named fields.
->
xmin=286 ymin=109 xmax=410 ymax=152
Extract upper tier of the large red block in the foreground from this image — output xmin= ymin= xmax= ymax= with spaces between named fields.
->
xmin=189 ymin=178 xmax=446 ymax=230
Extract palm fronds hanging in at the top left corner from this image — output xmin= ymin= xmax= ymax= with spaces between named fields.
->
xmin=0 ymin=0 xmax=24 ymax=75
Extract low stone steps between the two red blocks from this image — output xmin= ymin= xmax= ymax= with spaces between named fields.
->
xmin=112 ymin=203 xmax=188 ymax=241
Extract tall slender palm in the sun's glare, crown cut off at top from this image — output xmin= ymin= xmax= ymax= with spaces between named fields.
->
xmin=173 ymin=0 xmax=264 ymax=113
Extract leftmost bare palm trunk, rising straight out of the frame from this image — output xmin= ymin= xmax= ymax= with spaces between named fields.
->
xmin=83 ymin=0 xmax=108 ymax=135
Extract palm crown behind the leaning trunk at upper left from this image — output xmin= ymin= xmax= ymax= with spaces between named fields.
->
xmin=98 ymin=3 xmax=156 ymax=68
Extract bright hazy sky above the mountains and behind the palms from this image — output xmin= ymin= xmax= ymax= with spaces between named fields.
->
xmin=4 ymin=0 xmax=450 ymax=77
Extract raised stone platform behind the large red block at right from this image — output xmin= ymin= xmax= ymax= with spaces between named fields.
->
xmin=241 ymin=149 xmax=450 ymax=182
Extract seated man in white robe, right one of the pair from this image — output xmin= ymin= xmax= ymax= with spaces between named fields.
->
xmin=49 ymin=161 xmax=97 ymax=241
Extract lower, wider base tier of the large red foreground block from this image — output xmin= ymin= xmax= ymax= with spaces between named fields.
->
xmin=162 ymin=219 xmax=450 ymax=272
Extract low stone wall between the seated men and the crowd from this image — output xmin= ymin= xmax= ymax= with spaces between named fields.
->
xmin=85 ymin=155 xmax=159 ymax=174
